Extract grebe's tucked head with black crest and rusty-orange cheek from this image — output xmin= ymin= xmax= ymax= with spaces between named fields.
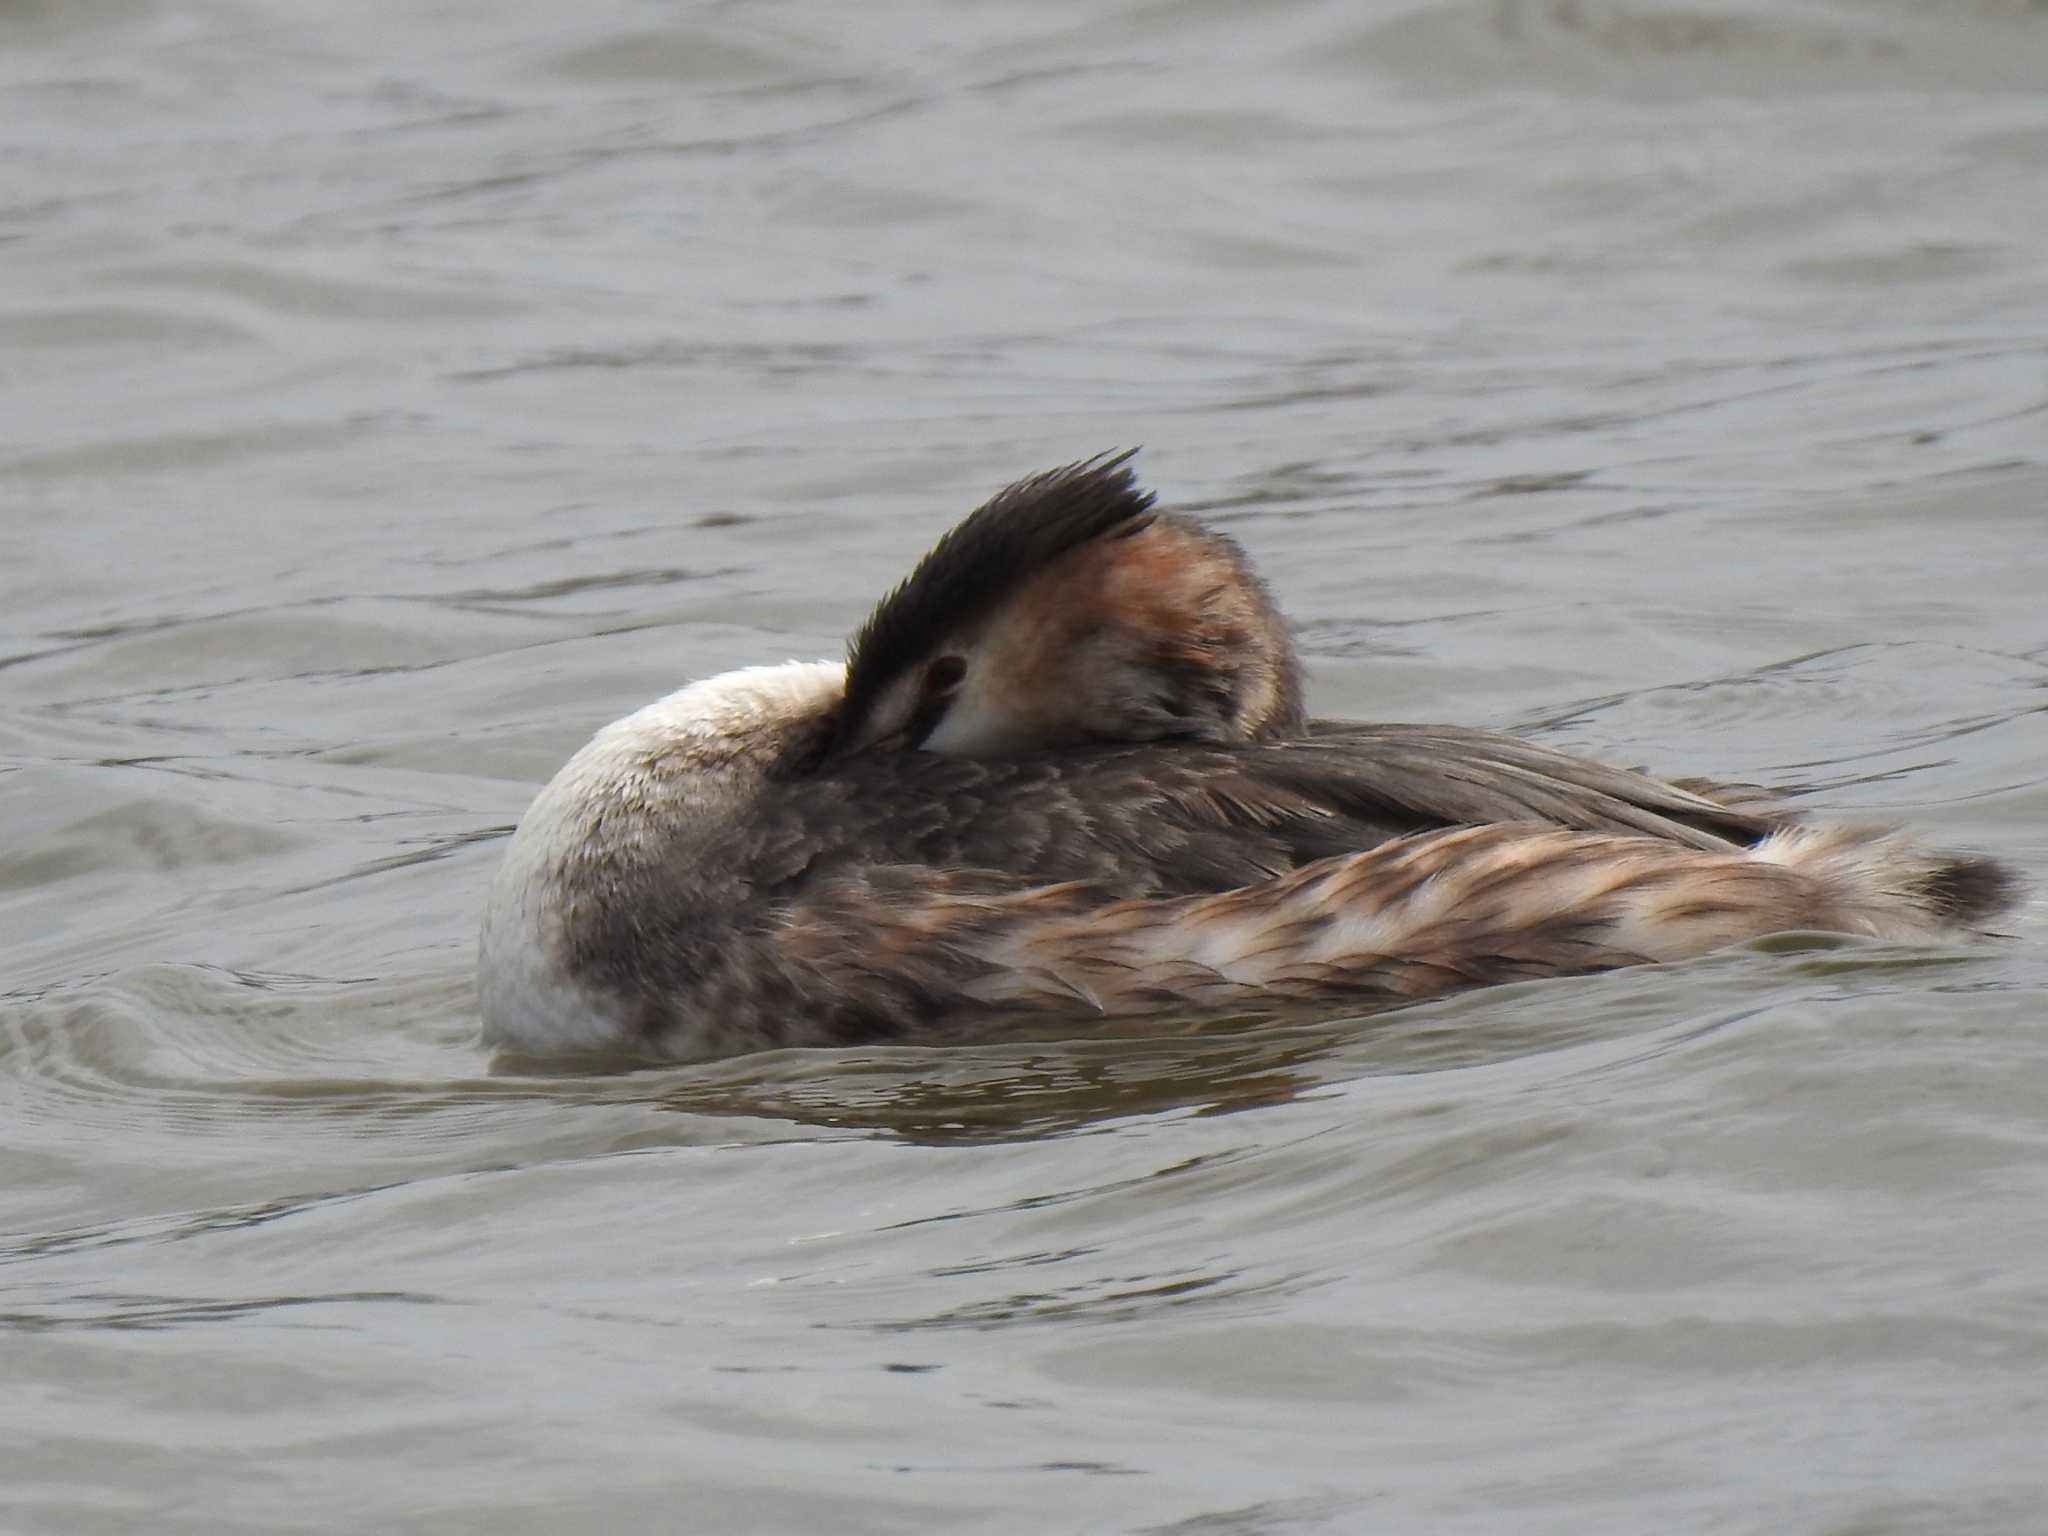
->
xmin=827 ymin=453 xmax=1305 ymax=756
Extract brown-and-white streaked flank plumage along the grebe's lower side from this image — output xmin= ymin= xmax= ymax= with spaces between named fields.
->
xmin=651 ymin=825 xmax=2011 ymax=1038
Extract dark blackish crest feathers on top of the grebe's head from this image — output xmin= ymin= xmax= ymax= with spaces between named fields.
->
xmin=827 ymin=449 xmax=1153 ymax=750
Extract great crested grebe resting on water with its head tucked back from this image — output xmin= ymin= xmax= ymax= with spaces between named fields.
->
xmin=479 ymin=455 xmax=2015 ymax=1061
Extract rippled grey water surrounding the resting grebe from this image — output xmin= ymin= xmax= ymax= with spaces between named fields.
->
xmin=0 ymin=0 xmax=2048 ymax=1536
